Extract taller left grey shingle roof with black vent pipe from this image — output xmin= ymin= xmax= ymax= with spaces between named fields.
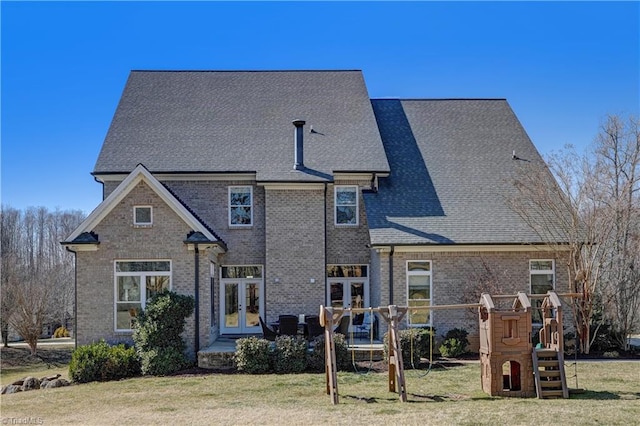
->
xmin=94 ymin=71 xmax=389 ymax=181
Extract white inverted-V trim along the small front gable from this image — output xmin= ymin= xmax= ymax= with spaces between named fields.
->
xmin=65 ymin=164 xmax=218 ymax=242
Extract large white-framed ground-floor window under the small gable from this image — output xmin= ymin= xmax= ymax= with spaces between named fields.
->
xmin=114 ymin=260 xmax=171 ymax=331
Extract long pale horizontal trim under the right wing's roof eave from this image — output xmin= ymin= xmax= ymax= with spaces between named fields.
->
xmin=372 ymin=244 xmax=569 ymax=253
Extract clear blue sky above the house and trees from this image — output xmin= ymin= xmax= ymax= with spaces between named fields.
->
xmin=0 ymin=1 xmax=640 ymax=213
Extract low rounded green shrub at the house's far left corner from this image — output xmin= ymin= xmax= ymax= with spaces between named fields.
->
xmin=69 ymin=340 xmax=140 ymax=383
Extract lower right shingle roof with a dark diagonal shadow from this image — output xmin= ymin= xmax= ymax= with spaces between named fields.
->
xmin=365 ymin=99 xmax=542 ymax=245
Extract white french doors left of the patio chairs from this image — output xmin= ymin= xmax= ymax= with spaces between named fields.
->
xmin=220 ymin=278 xmax=264 ymax=334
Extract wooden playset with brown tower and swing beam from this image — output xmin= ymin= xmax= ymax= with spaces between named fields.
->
xmin=320 ymin=291 xmax=579 ymax=404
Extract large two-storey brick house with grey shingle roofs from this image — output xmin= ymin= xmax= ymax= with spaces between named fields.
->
xmin=63 ymin=71 xmax=568 ymax=353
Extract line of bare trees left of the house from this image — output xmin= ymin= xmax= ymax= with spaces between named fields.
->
xmin=0 ymin=205 xmax=85 ymax=354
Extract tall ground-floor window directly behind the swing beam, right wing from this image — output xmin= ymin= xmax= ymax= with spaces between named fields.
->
xmin=407 ymin=261 xmax=431 ymax=326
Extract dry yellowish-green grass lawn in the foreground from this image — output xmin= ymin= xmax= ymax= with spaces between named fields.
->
xmin=0 ymin=348 xmax=640 ymax=425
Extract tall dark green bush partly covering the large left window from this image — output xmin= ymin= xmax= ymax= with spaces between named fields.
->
xmin=133 ymin=291 xmax=195 ymax=375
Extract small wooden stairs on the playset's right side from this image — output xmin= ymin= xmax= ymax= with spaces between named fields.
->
xmin=532 ymin=349 xmax=569 ymax=399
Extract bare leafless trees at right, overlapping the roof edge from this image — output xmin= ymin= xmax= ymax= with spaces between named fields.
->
xmin=508 ymin=116 xmax=640 ymax=353
